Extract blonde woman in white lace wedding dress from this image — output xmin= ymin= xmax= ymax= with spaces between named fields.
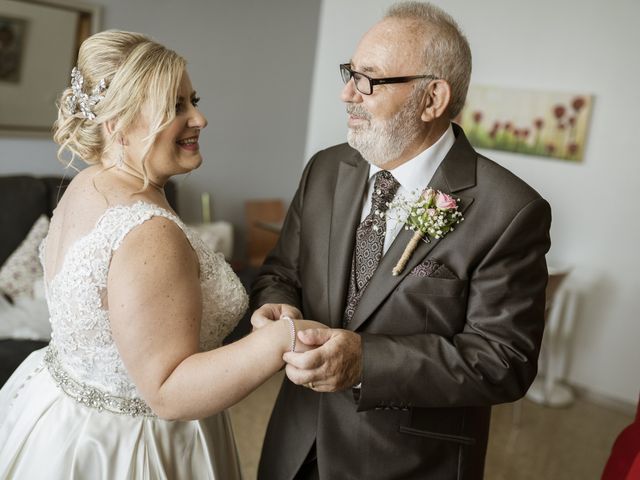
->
xmin=0 ymin=31 xmax=322 ymax=480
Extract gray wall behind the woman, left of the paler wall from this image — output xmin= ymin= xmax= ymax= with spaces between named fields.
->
xmin=0 ymin=0 xmax=320 ymax=254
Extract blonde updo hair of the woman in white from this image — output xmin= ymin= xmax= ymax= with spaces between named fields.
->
xmin=53 ymin=30 xmax=186 ymax=166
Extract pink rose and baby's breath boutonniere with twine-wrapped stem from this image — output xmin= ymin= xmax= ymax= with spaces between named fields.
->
xmin=389 ymin=188 xmax=464 ymax=276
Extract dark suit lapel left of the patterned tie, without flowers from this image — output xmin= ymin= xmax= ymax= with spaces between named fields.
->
xmin=327 ymin=152 xmax=369 ymax=327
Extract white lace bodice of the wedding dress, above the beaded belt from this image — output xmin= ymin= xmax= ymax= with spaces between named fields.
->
xmin=40 ymin=202 xmax=247 ymax=398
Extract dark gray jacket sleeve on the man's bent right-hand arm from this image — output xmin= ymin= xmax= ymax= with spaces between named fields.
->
xmin=358 ymin=197 xmax=551 ymax=411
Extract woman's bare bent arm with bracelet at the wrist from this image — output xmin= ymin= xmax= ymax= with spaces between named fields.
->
xmin=107 ymin=217 xmax=315 ymax=419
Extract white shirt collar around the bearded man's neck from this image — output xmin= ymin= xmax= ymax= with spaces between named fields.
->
xmin=369 ymin=123 xmax=456 ymax=192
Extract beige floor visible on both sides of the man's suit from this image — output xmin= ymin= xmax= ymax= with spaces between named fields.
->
xmin=231 ymin=374 xmax=633 ymax=480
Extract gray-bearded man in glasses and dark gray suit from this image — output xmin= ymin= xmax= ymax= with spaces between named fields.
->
xmin=251 ymin=2 xmax=551 ymax=480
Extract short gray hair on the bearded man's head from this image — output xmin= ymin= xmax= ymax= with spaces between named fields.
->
xmin=384 ymin=1 xmax=471 ymax=118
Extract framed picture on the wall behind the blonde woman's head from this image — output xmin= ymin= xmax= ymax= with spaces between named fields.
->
xmin=0 ymin=0 xmax=102 ymax=137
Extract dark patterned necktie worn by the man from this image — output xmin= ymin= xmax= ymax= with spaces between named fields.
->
xmin=343 ymin=170 xmax=400 ymax=326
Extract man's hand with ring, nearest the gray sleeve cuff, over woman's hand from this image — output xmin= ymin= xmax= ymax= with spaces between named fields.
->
xmin=283 ymin=328 xmax=362 ymax=392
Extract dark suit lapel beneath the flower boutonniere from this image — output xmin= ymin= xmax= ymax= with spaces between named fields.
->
xmin=349 ymin=124 xmax=477 ymax=330
